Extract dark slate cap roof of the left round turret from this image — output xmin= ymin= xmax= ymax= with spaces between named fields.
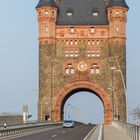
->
xmin=36 ymin=0 xmax=57 ymax=8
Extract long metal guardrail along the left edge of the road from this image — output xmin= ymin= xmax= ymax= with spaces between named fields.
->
xmin=0 ymin=122 xmax=62 ymax=137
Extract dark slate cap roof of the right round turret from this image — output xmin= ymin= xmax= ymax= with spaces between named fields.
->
xmin=108 ymin=0 xmax=129 ymax=8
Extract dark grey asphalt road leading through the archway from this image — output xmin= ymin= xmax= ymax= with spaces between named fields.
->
xmin=12 ymin=125 xmax=94 ymax=140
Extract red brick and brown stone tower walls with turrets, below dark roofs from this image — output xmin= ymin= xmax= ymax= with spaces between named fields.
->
xmin=37 ymin=1 xmax=128 ymax=124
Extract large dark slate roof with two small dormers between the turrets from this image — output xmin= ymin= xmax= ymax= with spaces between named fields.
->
xmin=56 ymin=0 xmax=108 ymax=25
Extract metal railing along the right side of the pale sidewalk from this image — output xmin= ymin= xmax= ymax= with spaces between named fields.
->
xmin=113 ymin=121 xmax=140 ymax=140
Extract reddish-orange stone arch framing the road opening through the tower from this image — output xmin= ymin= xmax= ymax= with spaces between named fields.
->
xmin=52 ymin=81 xmax=112 ymax=124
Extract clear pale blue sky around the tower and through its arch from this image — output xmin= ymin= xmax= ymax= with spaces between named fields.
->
xmin=0 ymin=0 xmax=140 ymax=123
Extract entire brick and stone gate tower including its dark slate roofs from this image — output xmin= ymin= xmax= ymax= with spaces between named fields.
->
xmin=36 ymin=0 xmax=128 ymax=124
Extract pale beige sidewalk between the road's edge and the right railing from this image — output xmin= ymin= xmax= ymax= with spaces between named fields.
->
xmin=104 ymin=125 xmax=131 ymax=140
